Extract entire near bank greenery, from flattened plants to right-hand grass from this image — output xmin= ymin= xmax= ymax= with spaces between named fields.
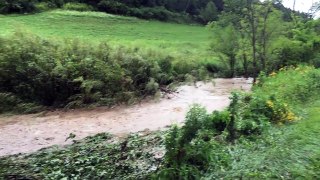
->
xmin=0 ymin=66 xmax=320 ymax=179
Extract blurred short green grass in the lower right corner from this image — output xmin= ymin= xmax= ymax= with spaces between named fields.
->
xmin=205 ymin=101 xmax=320 ymax=179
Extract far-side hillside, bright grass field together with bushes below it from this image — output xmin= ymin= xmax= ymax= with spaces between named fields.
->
xmin=0 ymin=10 xmax=218 ymax=112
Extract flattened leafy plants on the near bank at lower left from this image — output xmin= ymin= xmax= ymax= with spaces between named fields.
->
xmin=0 ymin=133 xmax=164 ymax=179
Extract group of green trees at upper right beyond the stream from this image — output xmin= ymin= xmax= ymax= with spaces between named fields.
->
xmin=208 ymin=0 xmax=320 ymax=77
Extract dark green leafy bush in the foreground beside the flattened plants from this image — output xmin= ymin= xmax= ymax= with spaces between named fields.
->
xmin=157 ymin=105 xmax=228 ymax=179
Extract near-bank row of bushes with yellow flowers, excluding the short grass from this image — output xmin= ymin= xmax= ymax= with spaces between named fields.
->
xmin=157 ymin=66 xmax=320 ymax=179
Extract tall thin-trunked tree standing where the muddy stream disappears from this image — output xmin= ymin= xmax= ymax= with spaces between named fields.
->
xmin=217 ymin=0 xmax=286 ymax=78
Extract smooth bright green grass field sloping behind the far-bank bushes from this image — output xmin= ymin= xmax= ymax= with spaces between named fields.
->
xmin=0 ymin=10 xmax=214 ymax=58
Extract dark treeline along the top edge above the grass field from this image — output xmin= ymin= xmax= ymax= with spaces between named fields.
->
xmin=0 ymin=0 xmax=308 ymax=24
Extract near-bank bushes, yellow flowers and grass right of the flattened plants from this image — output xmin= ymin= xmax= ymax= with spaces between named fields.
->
xmin=158 ymin=67 xmax=320 ymax=179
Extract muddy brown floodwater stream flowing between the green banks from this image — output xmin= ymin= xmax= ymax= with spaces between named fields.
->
xmin=0 ymin=78 xmax=252 ymax=156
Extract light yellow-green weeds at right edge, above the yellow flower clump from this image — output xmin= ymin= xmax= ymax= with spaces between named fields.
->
xmin=254 ymin=66 xmax=320 ymax=105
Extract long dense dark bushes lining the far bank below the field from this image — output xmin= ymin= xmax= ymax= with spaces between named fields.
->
xmin=0 ymin=33 xmax=208 ymax=111
